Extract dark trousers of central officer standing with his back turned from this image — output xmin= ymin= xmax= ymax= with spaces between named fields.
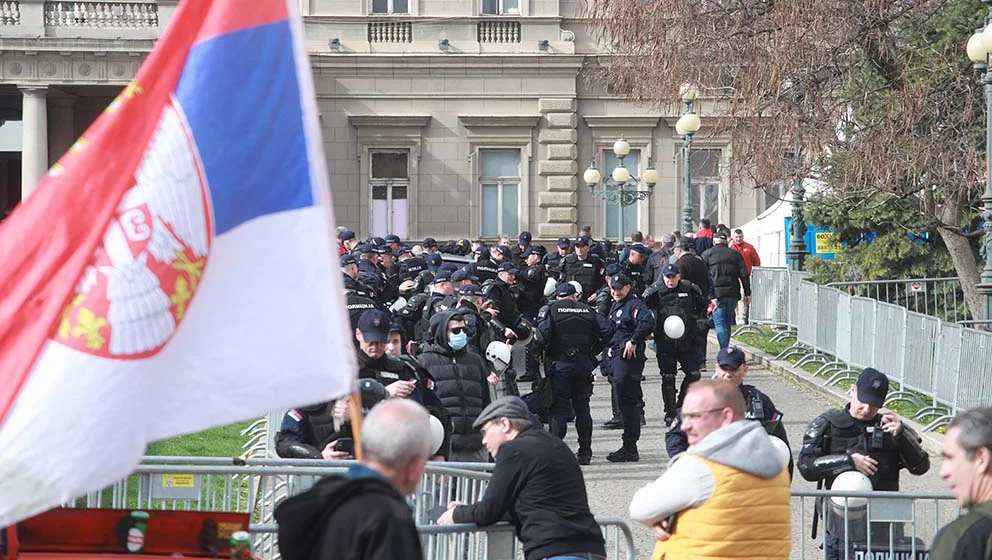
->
xmin=551 ymin=356 xmax=593 ymax=449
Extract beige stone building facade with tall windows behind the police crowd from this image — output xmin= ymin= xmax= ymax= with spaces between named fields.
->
xmin=0 ymin=0 xmax=773 ymax=240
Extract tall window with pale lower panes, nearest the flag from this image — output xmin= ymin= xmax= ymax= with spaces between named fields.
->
xmin=369 ymin=150 xmax=410 ymax=239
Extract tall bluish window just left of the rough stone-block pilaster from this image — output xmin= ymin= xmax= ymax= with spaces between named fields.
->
xmin=479 ymin=150 xmax=520 ymax=237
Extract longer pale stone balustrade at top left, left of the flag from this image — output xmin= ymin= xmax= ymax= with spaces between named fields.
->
xmin=45 ymin=1 xmax=158 ymax=29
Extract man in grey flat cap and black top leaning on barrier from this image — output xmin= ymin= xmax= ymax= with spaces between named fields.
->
xmin=438 ymin=396 xmax=606 ymax=560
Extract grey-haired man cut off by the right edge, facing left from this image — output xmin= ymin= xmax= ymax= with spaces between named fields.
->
xmin=930 ymin=406 xmax=992 ymax=560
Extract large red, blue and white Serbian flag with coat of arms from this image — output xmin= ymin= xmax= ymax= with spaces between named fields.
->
xmin=0 ymin=0 xmax=355 ymax=526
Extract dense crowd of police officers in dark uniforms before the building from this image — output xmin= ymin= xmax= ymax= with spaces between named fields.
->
xmin=277 ymin=223 xmax=756 ymax=464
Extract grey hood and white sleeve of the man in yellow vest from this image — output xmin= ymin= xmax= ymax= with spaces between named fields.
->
xmin=630 ymin=420 xmax=789 ymax=526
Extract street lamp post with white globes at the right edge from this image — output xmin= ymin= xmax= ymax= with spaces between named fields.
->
xmin=967 ymin=8 xmax=992 ymax=321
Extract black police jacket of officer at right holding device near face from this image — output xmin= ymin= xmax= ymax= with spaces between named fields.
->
xmin=799 ymin=404 xmax=930 ymax=491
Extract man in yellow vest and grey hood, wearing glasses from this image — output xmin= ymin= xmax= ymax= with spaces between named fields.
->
xmin=630 ymin=380 xmax=792 ymax=560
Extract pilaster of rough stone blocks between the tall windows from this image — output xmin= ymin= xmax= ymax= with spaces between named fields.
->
xmin=537 ymin=98 xmax=579 ymax=239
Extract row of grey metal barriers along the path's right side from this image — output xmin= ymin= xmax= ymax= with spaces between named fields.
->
xmin=752 ymin=268 xmax=992 ymax=430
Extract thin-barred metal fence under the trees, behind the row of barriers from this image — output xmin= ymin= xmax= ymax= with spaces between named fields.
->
xmin=827 ymin=277 xmax=971 ymax=323
